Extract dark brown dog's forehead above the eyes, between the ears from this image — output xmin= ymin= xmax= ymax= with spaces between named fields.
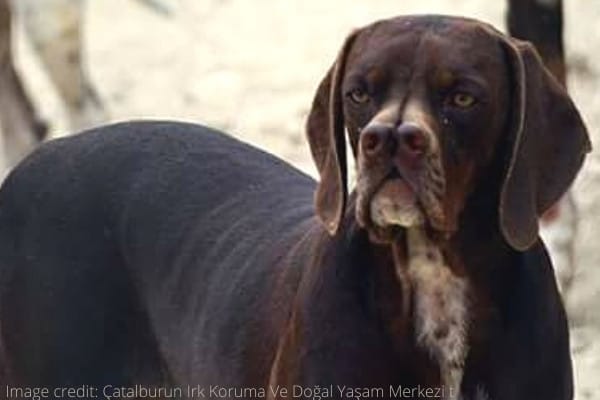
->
xmin=347 ymin=16 xmax=504 ymax=79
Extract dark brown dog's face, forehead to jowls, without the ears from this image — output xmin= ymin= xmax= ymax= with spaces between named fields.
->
xmin=342 ymin=21 xmax=510 ymax=239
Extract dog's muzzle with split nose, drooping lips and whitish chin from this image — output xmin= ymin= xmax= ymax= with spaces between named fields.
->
xmin=357 ymin=123 xmax=439 ymax=234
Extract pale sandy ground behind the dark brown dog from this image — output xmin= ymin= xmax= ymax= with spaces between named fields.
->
xmin=8 ymin=0 xmax=600 ymax=400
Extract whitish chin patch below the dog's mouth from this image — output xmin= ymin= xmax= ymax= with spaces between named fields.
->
xmin=370 ymin=179 xmax=425 ymax=228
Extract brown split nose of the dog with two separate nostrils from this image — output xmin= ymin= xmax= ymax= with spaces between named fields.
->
xmin=360 ymin=123 xmax=427 ymax=161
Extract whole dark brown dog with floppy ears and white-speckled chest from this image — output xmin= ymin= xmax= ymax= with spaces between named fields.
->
xmin=0 ymin=15 xmax=590 ymax=400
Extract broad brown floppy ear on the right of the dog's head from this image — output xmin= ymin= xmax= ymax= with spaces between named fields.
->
xmin=499 ymin=38 xmax=591 ymax=250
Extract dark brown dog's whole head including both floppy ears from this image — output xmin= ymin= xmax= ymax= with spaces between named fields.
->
xmin=307 ymin=16 xmax=590 ymax=250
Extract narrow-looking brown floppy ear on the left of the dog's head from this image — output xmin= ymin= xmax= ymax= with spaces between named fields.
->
xmin=306 ymin=31 xmax=359 ymax=235
